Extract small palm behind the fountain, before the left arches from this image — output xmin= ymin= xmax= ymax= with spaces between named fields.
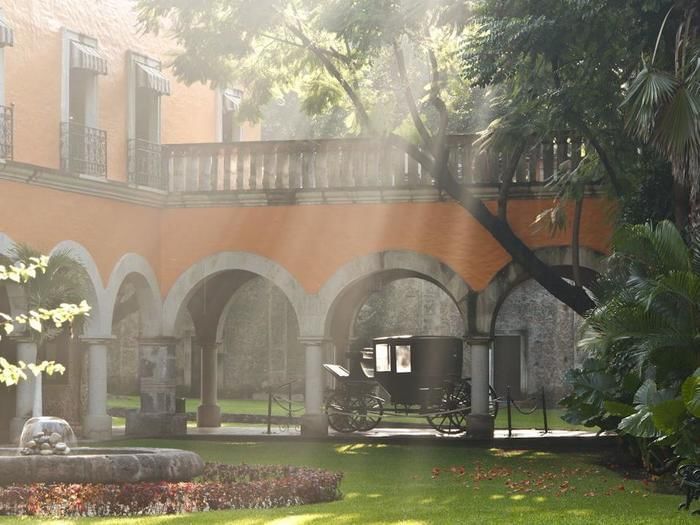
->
xmin=8 ymin=243 xmax=88 ymax=416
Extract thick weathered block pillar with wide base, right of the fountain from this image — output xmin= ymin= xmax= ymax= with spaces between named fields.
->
xmin=126 ymin=337 xmax=187 ymax=437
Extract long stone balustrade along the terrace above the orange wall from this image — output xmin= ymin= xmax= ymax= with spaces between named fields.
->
xmin=162 ymin=134 xmax=586 ymax=192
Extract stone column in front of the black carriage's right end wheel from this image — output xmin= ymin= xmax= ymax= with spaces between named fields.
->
xmin=467 ymin=336 xmax=493 ymax=439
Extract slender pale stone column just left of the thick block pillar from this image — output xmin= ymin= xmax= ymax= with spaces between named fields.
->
xmin=81 ymin=336 xmax=114 ymax=440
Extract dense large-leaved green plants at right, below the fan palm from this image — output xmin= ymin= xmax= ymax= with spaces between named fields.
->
xmin=564 ymin=221 xmax=700 ymax=468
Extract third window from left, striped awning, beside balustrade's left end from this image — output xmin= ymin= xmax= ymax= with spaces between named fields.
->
xmin=128 ymin=53 xmax=170 ymax=189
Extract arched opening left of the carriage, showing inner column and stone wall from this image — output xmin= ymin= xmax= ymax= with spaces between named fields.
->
xmin=166 ymin=269 xmax=304 ymax=427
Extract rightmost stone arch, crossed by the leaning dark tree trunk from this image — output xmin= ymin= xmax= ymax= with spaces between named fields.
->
xmin=470 ymin=246 xmax=606 ymax=336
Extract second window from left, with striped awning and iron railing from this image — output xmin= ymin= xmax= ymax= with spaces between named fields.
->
xmin=61 ymin=29 xmax=107 ymax=177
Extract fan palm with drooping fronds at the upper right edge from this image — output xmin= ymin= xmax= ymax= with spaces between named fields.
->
xmin=623 ymin=0 xmax=700 ymax=238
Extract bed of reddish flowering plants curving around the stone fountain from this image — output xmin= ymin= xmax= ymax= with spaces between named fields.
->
xmin=0 ymin=463 xmax=342 ymax=517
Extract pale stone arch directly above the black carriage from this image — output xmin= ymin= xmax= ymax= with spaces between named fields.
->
xmin=316 ymin=250 xmax=469 ymax=336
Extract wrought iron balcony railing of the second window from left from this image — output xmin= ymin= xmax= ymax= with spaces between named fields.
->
xmin=61 ymin=122 xmax=107 ymax=177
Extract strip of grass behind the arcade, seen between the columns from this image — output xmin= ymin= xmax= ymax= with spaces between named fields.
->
xmin=108 ymin=396 xmax=591 ymax=430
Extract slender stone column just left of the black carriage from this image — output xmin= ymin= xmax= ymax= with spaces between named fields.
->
xmin=299 ymin=337 xmax=328 ymax=436
